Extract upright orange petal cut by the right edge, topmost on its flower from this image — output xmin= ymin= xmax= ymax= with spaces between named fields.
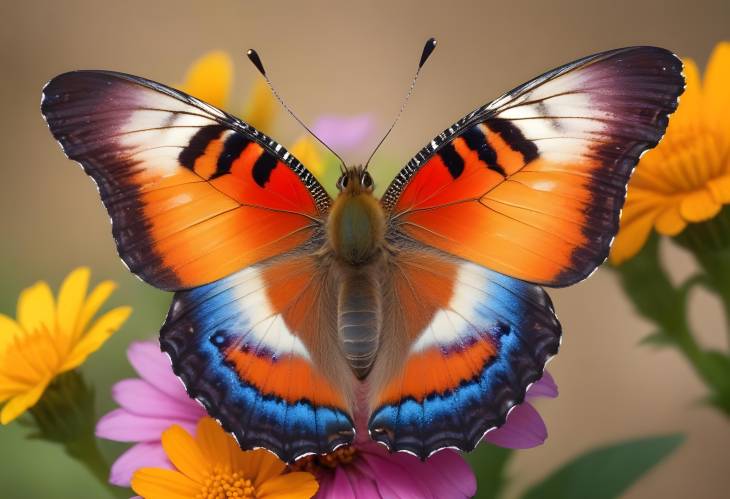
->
xmin=704 ymin=42 xmax=730 ymax=134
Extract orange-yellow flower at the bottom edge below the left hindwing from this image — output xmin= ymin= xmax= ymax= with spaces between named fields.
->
xmin=132 ymin=417 xmax=319 ymax=499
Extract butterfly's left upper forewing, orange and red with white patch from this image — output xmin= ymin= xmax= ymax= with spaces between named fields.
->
xmin=41 ymin=71 xmax=330 ymax=290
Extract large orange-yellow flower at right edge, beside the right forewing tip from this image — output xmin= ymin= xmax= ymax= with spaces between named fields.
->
xmin=611 ymin=42 xmax=730 ymax=264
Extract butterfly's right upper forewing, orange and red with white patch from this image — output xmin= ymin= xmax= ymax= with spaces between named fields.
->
xmin=382 ymin=47 xmax=684 ymax=286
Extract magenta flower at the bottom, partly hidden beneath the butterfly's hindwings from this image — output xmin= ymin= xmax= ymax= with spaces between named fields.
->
xmin=291 ymin=372 xmax=558 ymax=499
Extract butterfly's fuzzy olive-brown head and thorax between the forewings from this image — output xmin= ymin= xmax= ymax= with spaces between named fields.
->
xmin=327 ymin=167 xmax=385 ymax=266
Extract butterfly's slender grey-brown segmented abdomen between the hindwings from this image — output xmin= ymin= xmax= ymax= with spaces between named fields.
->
xmin=337 ymin=267 xmax=383 ymax=379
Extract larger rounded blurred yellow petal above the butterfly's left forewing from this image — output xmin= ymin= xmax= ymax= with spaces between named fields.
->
xmin=180 ymin=51 xmax=233 ymax=108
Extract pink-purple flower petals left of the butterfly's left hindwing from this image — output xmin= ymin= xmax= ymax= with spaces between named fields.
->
xmin=96 ymin=341 xmax=206 ymax=487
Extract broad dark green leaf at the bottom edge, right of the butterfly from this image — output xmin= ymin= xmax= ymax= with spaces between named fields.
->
xmin=522 ymin=435 xmax=684 ymax=499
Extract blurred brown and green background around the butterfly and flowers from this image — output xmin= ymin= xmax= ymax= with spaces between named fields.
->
xmin=0 ymin=0 xmax=730 ymax=499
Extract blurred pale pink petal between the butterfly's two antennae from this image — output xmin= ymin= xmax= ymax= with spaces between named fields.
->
xmin=312 ymin=114 xmax=375 ymax=154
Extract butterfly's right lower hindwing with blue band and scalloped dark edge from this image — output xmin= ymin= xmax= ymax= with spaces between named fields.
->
xmin=369 ymin=244 xmax=561 ymax=458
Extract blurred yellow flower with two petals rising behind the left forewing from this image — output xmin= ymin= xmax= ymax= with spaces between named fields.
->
xmin=179 ymin=51 xmax=278 ymax=134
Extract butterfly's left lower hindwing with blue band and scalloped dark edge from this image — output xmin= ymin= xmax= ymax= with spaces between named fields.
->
xmin=160 ymin=248 xmax=354 ymax=462
